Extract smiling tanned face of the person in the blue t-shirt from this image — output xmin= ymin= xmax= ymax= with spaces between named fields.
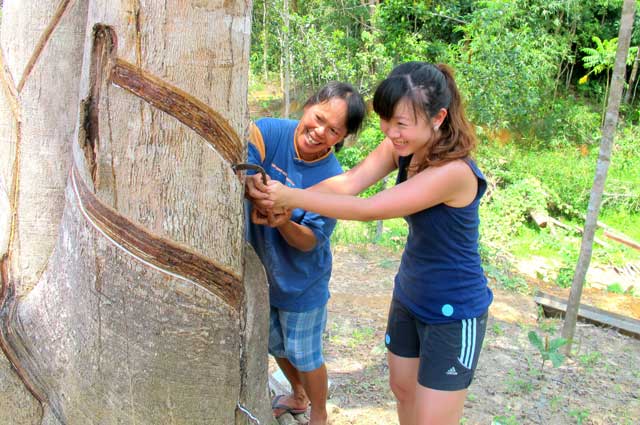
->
xmin=295 ymin=98 xmax=347 ymax=161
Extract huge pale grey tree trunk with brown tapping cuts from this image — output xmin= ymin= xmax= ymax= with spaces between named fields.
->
xmin=0 ymin=0 xmax=271 ymax=425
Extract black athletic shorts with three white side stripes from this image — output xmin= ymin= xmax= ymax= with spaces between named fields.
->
xmin=385 ymin=298 xmax=487 ymax=391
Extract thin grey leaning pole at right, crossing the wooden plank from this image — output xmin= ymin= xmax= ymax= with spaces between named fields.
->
xmin=562 ymin=0 xmax=636 ymax=354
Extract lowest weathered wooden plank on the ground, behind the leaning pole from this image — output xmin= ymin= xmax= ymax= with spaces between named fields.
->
xmin=534 ymin=292 xmax=640 ymax=339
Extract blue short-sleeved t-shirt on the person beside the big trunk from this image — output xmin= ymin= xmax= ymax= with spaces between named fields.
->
xmin=247 ymin=118 xmax=342 ymax=312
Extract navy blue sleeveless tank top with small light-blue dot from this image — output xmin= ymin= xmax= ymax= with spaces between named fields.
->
xmin=393 ymin=155 xmax=493 ymax=324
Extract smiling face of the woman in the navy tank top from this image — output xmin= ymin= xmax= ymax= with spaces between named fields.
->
xmin=380 ymin=99 xmax=446 ymax=156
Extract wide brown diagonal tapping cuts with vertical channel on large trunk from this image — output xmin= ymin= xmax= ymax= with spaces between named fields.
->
xmin=79 ymin=25 xmax=244 ymax=311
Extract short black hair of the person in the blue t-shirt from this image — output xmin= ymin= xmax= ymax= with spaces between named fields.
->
xmin=304 ymin=81 xmax=367 ymax=152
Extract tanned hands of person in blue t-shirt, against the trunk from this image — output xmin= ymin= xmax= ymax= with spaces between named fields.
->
xmin=245 ymin=174 xmax=291 ymax=227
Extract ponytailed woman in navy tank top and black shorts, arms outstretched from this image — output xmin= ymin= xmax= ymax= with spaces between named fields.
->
xmin=260 ymin=62 xmax=492 ymax=425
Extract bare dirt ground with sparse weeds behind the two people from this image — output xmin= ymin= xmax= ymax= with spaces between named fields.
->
xmin=312 ymin=243 xmax=640 ymax=425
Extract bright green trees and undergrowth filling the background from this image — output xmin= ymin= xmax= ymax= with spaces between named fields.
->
xmin=251 ymin=0 xmax=640 ymax=292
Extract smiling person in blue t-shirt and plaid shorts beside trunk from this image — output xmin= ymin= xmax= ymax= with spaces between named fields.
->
xmin=246 ymin=82 xmax=366 ymax=425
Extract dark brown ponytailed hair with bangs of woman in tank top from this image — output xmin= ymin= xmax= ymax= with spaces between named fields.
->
xmin=373 ymin=61 xmax=477 ymax=171
